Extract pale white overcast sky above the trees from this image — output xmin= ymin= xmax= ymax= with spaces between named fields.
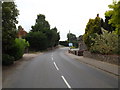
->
xmin=15 ymin=0 xmax=113 ymax=40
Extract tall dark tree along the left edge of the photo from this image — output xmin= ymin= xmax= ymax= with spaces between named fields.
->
xmin=2 ymin=1 xmax=19 ymax=53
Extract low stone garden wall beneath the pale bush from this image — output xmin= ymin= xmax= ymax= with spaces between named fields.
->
xmin=83 ymin=51 xmax=120 ymax=65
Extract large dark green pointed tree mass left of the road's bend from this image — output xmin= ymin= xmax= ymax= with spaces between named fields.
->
xmin=25 ymin=14 xmax=60 ymax=51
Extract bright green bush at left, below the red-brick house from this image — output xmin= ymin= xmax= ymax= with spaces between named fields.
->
xmin=10 ymin=38 xmax=29 ymax=60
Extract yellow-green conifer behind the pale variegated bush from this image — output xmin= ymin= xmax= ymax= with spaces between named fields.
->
xmin=83 ymin=17 xmax=102 ymax=50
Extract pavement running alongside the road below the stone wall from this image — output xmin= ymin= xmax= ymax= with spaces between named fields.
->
xmin=66 ymin=52 xmax=120 ymax=76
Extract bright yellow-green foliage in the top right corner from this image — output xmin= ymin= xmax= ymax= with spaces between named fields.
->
xmin=105 ymin=1 xmax=120 ymax=35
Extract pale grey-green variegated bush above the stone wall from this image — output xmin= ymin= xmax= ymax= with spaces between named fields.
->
xmin=90 ymin=29 xmax=120 ymax=54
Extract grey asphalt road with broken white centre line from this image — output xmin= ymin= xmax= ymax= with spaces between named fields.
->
xmin=3 ymin=48 xmax=118 ymax=88
